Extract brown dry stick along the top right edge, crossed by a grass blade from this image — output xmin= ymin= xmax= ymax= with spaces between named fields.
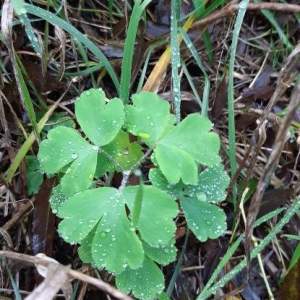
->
xmin=192 ymin=2 xmax=300 ymax=28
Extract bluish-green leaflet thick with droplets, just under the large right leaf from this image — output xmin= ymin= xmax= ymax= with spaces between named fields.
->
xmin=185 ymin=164 xmax=229 ymax=203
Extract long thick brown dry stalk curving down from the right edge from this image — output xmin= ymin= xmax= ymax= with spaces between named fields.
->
xmin=245 ymin=79 xmax=300 ymax=267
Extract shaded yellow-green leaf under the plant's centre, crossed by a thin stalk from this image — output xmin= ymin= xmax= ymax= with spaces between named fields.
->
xmin=96 ymin=130 xmax=143 ymax=177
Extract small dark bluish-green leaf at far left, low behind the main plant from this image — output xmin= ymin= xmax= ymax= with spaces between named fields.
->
xmin=26 ymin=155 xmax=43 ymax=195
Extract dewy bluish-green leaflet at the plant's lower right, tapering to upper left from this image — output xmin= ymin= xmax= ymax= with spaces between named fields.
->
xmin=180 ymin=198 xmax=226 ymax=242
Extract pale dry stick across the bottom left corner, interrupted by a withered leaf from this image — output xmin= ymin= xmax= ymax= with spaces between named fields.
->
xmin=0 ymin=251 xmax=133 ymax=300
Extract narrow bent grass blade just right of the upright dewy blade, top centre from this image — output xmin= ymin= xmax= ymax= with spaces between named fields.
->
xmin=179 ymin=29 xmax=210 ymax=117
